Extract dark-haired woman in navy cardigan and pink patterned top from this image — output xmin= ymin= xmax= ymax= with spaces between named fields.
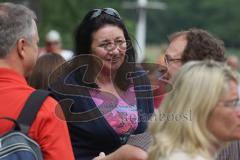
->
xmin=50 ymin=8 xmax=153 ymax=160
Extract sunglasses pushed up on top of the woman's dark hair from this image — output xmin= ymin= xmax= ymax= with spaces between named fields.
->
xmin=90 ymin=8 xmax=121 ymax=19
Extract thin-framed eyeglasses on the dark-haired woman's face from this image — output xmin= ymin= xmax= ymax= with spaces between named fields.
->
xmin=99 ymin=40 xmax=131 ymax=51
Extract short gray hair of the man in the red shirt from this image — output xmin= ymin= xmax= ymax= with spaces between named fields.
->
xmin=0 ymin=3 xmax=37 ymax=58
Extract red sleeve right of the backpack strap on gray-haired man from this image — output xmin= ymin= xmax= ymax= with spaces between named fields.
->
xmin=29 ymin=98 xmax=74 ymax=160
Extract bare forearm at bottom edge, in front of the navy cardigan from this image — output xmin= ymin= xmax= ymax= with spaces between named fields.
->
xmin=93 ymin=144 xmax=147 ymax=160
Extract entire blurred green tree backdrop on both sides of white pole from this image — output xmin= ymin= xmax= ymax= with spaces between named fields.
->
xmin=0 ymin=0 xmax=240 ymax=59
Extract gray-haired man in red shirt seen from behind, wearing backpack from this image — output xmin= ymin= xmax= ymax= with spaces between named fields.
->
xmin=0 ymin=3 xmax=74 ymax=160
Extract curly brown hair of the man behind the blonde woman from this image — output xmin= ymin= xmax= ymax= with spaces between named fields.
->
xmin=170 ymin=28 xmax=226 ymax=63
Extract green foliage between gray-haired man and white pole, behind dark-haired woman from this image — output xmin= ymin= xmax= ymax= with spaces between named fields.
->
xmin=39 ymin=0 xmax=134 ymax=48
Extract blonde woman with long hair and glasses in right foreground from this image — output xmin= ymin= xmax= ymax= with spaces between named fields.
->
xmin=148 ymin=61 xmax=240 ymax=160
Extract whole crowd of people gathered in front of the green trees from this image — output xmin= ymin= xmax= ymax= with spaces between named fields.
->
xmin=0 ymin=3 xmax=240 ymax=160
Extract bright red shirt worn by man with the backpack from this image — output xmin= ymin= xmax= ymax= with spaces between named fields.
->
xmin=0 ymin=68 xmax=74 ymax=160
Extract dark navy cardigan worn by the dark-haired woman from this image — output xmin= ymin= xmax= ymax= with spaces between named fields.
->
xmin=52 ymin=65 xmax=154 ymax=159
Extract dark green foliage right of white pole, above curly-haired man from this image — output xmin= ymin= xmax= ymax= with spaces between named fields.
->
xmin=148 ymin=0 xmax=240 ymax=48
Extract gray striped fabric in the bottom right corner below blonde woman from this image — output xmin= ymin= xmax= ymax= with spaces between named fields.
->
xmin=216 ymin=141 xmax=240 ymax=160
